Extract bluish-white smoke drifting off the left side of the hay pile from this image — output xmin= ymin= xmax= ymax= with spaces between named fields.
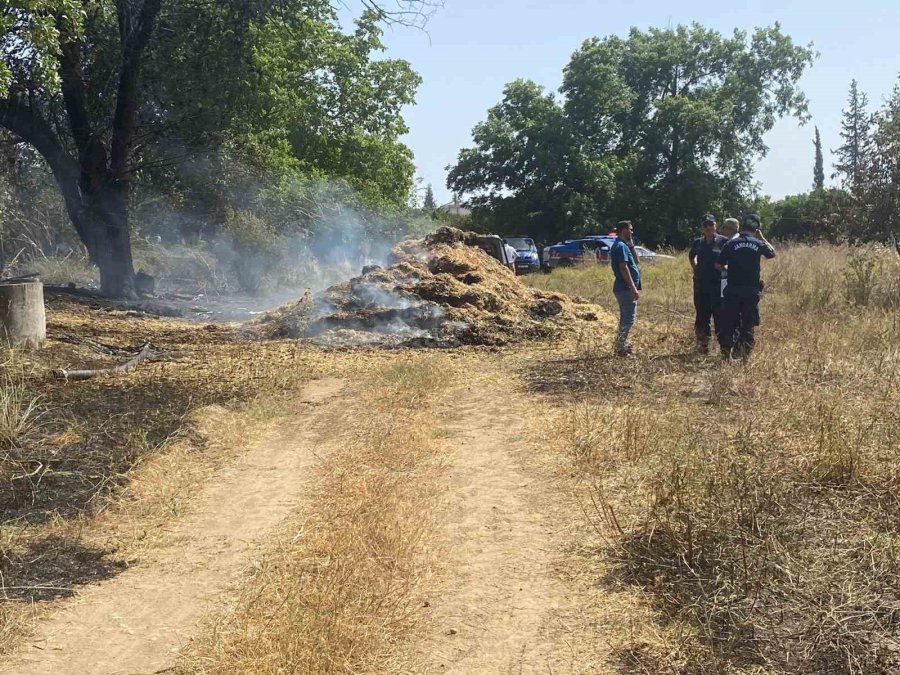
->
xmin=133 ymin=147 xmax=434 ymax=321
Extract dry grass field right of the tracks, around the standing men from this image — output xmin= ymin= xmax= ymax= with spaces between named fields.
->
xmin=534 ymin=246 xmax=900 ymax=673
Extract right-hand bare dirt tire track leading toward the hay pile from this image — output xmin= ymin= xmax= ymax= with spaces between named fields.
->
xmin=411 ymin=366 xmax=607 ymax=674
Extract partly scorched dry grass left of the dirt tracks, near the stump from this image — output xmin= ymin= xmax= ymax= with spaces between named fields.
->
xmin=0 ymin=297 xmax=340 ymax=651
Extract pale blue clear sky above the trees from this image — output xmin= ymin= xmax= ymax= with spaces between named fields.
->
xmin=342 ymin=0 xmax=900 ymax=202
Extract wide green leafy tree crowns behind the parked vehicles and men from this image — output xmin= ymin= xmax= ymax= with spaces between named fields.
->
xmin=448 ymin=24 xmax=813 ymax=244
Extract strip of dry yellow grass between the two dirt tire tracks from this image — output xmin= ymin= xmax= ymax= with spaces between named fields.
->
xmin=181 ymin=357 xmax=452 ymax=674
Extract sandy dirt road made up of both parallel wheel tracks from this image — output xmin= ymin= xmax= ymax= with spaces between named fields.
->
xmin=0 ymin=358 xmax=607 ymax=675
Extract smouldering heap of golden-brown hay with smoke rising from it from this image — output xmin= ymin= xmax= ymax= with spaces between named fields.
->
xmin=255 ymin=227 xmax=602 ymax=346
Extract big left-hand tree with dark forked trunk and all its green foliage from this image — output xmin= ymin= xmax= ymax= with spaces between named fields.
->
xmin=0 ymin=0 xmax=425 ymax=294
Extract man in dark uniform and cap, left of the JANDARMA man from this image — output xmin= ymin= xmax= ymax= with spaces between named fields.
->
xmin=688 ymin=213 xmax=728 ymax=354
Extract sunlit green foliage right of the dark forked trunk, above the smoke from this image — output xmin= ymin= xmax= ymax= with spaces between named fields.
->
xmin=136 ymin=0 xmax=419 ymax=254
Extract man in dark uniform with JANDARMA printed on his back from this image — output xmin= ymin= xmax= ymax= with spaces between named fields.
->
xmin=716 ymin=213 xmax=775 ymax=359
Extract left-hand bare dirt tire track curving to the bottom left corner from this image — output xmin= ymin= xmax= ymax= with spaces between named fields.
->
xmin=0 ymin=379 xmax=344 ymax=675
